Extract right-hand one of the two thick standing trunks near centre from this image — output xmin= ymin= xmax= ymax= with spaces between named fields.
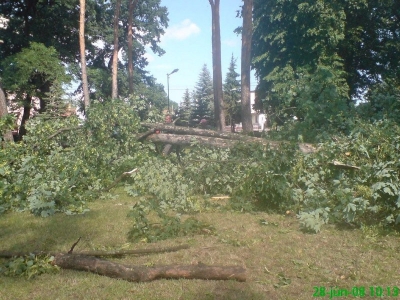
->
xmin=241 ymin=0 xmax=253 ymax=132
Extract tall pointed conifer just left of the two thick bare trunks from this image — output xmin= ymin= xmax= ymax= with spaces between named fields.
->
xmin=191 ymin=64 xmax=215 ymax=126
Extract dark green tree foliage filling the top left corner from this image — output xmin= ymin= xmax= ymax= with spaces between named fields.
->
xmin=0 ymin=0 xmax=81 ymax=63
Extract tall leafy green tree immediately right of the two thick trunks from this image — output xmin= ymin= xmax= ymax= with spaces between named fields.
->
xmin=252 ymin=0 xmax=348 ymax=131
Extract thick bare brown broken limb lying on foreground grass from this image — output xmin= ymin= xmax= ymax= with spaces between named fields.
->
xmin=52 ymin=254 xmax=246 ymax=282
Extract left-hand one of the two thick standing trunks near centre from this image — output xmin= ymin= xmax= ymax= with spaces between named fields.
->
xmin=209 ymin=0 xmax=225 ymax=131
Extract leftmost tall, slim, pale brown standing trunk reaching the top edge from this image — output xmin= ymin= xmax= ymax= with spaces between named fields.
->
xmin=79 ymin=0 xmax=90 ymax=111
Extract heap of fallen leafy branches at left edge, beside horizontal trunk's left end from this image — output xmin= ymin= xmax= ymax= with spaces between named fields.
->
xmin=0 ymin=101 xmax=150 ymax=216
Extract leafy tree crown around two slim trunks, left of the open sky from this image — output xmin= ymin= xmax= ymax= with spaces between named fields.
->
xmin=89 ymin=0 xmax=168 ymax=99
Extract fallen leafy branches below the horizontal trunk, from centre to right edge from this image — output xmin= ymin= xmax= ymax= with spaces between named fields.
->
xmin=125 ymin=120 xmax=400 ymax=232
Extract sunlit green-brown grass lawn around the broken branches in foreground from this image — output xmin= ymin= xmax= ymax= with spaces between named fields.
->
xmin=0 ymin=194 xmax=400 ymax=300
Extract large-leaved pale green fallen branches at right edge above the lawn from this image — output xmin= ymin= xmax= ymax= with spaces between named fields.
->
xmin=291 ymin=121 xmax=400 ymax=231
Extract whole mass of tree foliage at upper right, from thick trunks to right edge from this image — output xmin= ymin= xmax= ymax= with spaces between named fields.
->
xmin=252 ymin=0 xmax=400 ymax=136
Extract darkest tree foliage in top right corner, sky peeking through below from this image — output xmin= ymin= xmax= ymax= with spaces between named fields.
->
xmin=338 ymin=0 xmax=400 ymax=96
